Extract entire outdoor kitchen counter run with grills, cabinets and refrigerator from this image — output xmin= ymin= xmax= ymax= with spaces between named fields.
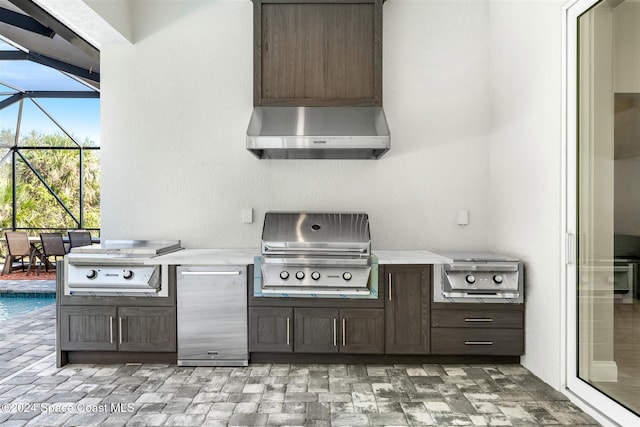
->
xmin=57 ymin=212 xmax=525 ymax=367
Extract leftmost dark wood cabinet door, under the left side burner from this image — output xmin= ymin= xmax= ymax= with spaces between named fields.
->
xmin=60 ymin=306 xmax=118 ymax=351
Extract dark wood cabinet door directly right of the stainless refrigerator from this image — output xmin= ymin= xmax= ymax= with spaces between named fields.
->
xmin=249 ymin=307 xmax=293 ymax=353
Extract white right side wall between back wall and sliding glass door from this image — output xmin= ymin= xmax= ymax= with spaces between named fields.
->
xmin=489 ymin=0 xmax=563 ymax=388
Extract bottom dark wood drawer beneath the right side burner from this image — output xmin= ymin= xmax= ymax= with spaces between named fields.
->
xmin=431 ymin=328 xmax=524 ymax=356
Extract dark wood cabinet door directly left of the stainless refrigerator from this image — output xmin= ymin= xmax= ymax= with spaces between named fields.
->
xmin=118 ymin=307 xmax=176 ymax=352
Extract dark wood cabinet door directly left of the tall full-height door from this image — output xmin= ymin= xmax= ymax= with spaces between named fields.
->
xmin=340 ymin=309 xmax=384 ymax=354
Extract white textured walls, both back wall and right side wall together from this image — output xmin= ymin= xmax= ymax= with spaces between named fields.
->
xmin=51 ymin=0 xmax=563 ymax=387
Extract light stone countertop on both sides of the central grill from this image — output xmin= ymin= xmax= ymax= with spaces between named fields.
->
xmin=145 ymin=248 xmax=451 ymax=265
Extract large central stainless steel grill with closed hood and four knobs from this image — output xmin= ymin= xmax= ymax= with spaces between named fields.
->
xmin=261 ymin=212 xmax=371 ymax=297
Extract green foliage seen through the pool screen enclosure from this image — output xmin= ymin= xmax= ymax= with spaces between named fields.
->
xmin=0 ymin=129 xmax=100 ymax=229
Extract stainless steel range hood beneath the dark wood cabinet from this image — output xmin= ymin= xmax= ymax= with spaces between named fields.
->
xmin=247 ymin=106 xmax=390 ymax=159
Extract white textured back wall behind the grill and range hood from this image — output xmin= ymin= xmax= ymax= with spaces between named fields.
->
xmin=101 ymin=0 xmax=489 ymax=250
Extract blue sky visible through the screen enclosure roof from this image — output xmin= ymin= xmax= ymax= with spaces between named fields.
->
xmin=0 ymin=40 xmax=100 ymax=145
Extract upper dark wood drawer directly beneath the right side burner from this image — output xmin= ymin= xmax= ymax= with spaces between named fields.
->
xmin=431 ymin=310 xmax=524 ymax=329
